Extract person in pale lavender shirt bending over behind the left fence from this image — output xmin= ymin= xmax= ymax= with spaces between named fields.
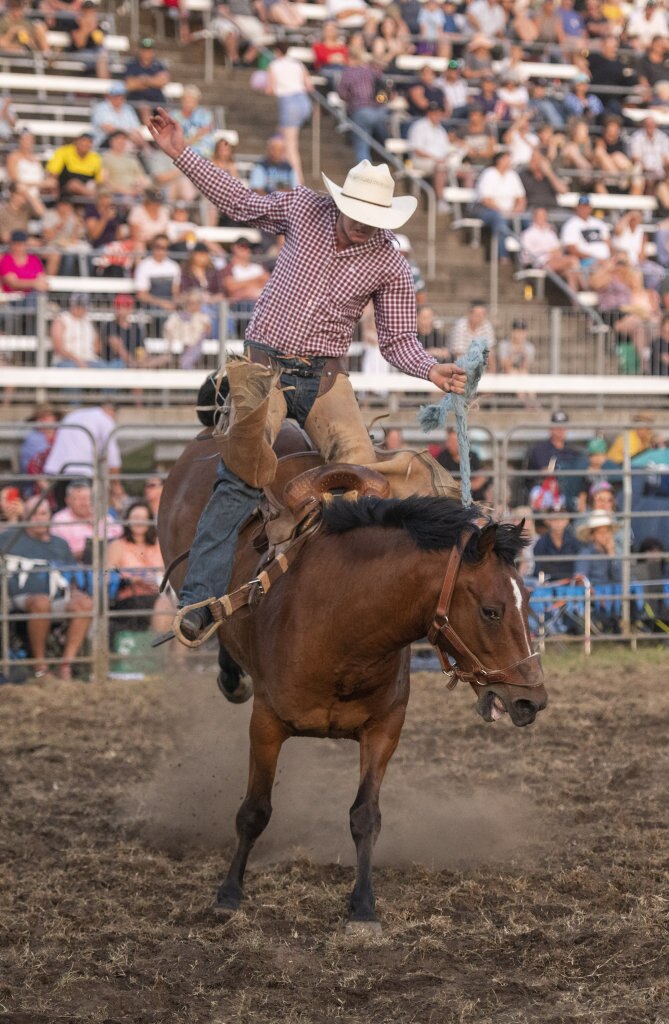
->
xmin=44 ymin=401 xmax=122 ymax=507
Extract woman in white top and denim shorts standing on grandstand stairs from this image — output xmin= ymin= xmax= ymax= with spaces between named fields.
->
xmin=264 ymin=40 xmax=313 ymax=184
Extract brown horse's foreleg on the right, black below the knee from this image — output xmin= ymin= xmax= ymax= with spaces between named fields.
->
xmin=348 ymin=707 xmax=405 ymax=922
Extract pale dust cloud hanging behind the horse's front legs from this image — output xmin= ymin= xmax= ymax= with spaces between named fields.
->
xmin=124 ymin=667 xmax=537 ymax=869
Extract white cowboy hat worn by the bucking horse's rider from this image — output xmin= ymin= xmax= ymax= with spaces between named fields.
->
xmin=323 ymin=160 xmax=418 ymax=231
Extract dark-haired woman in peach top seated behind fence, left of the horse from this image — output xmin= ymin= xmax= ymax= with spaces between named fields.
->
xmin=106 ymin=501 xmax=174 ymax=634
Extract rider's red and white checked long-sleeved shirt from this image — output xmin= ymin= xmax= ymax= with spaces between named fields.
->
xmin=174 ymin=147 xmax=436 ymax=378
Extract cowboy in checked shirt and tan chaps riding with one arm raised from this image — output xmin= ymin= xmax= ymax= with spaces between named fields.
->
xmin=149 ymin=108 xmax=465 ymax=640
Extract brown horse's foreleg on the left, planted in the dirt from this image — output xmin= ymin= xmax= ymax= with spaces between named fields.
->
xmin=216 ymin=699 xmax=288 ymax=911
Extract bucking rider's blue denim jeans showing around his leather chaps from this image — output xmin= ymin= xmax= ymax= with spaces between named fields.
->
xmin=179 ymin=345 xmax=325 ymax=607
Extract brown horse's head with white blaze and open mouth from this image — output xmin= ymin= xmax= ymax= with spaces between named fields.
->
xmin=430 ymin=523 xmax=548 ymax=725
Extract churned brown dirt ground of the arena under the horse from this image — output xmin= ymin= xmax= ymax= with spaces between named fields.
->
xmin=0 ymin=647 xmax=669 ymax=1024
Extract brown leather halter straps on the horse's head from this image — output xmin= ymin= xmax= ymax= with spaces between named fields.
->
xmin=427 ymin=519 xmax=543 ymax=690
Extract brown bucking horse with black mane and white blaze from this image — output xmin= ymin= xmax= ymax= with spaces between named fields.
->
xmin=159 ymin=428 xmax=547 ymax=928
